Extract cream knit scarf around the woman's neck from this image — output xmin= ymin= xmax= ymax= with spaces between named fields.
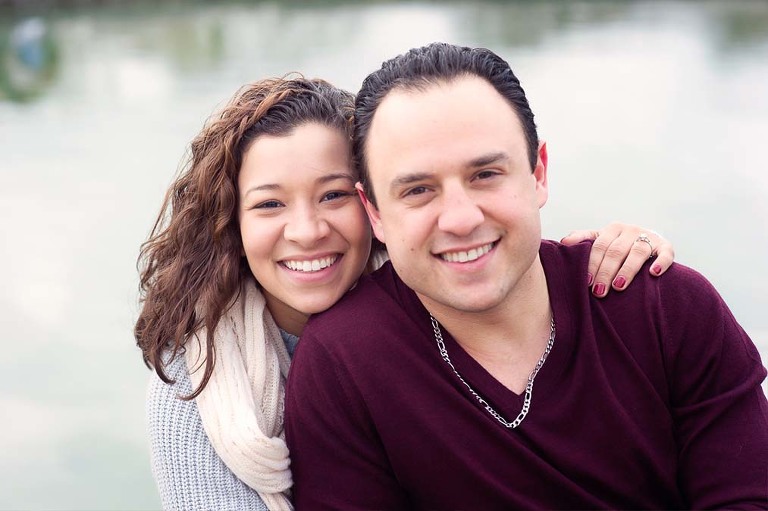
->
xmin=186 ymin=279 xmax=293 ymax=511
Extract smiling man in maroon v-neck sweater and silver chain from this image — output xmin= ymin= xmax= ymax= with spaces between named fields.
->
xmin=286 ymin=44 xmax=768 ymax=510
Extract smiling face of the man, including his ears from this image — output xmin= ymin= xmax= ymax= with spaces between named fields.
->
xmin=358 ymin=76 xmax=547 ymax=315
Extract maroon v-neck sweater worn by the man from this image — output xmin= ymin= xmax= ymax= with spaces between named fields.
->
xmin=286 ymin=241 xmax=768 ymax=510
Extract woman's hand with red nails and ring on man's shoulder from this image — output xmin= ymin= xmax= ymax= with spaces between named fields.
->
xmin=560 ymin=222 xmax=675 ymax=297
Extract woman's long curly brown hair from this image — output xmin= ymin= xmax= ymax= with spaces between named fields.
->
xmin=134 ymin=75 xmax=354 ymax=399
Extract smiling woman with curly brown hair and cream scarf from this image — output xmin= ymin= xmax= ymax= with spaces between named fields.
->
xmin=135 ymin=77 xmax=672 ymax=509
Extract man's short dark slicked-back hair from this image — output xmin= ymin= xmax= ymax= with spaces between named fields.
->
xmin=352 ymin=43 xmax=539 ymax=205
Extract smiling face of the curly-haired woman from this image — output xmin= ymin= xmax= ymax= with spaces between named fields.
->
xmin=238 ymin=123 xmax=371 ymax=335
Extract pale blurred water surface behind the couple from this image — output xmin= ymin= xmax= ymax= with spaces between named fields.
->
xmin=0 ymin=0 xmax=768 ymax=510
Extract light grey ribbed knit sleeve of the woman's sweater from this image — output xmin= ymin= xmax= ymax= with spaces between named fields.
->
xmin=147 ymin=357 xmax=267 ymax=511
